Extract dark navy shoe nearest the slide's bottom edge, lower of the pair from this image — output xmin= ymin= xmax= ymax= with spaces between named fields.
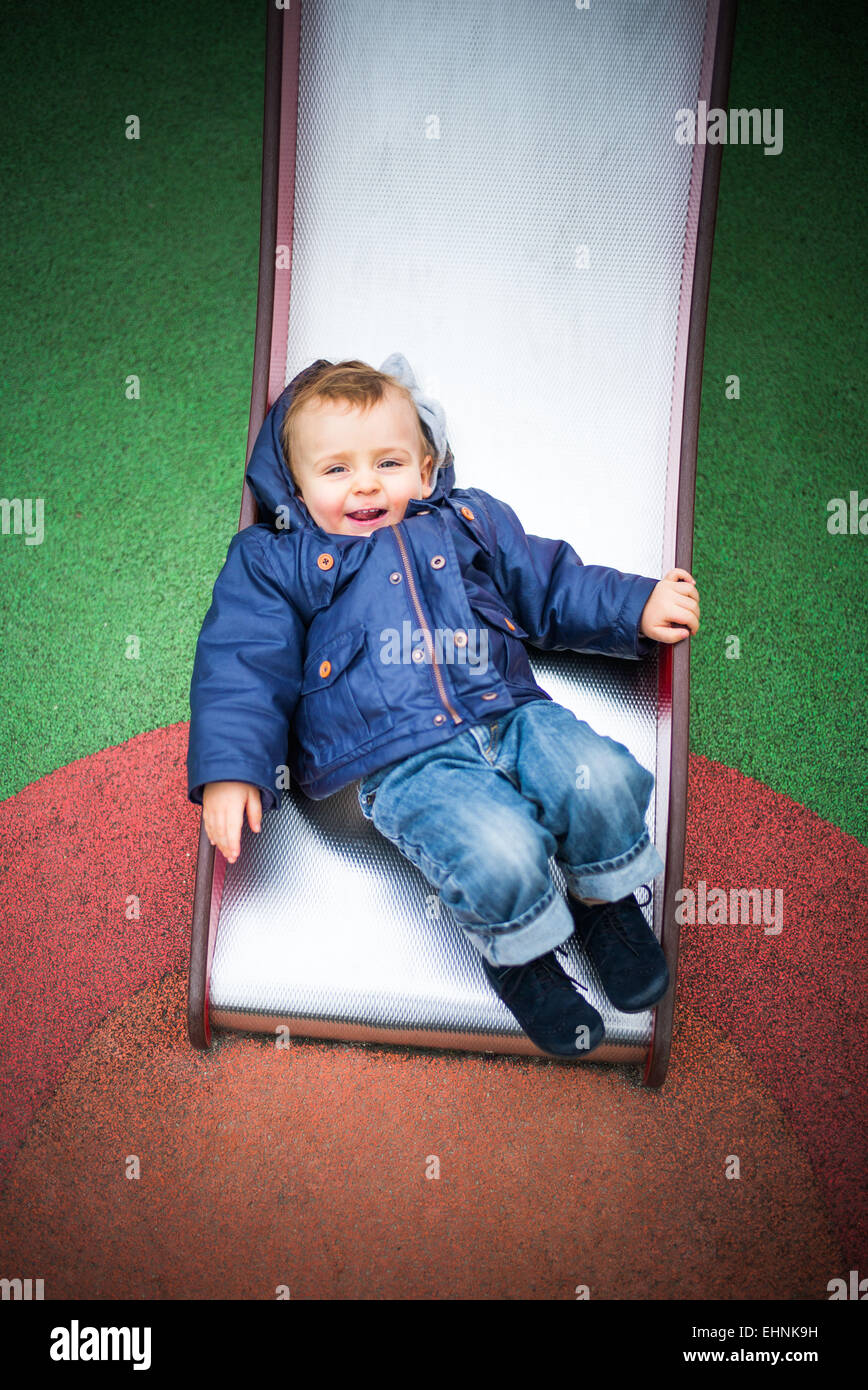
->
xmin=481 ymin=951 xmax=604 ymax=1058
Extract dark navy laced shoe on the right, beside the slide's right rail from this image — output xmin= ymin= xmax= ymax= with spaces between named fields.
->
xmin=568 ymin=884 xmax=669 ymax=1013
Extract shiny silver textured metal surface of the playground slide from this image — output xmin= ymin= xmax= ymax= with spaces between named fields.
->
xmin=191 ymin=0 xmax=734 ymax=1063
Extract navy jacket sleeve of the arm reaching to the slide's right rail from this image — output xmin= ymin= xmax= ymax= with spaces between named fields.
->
xmin=475 ymin=493 xmax=658 ymax=660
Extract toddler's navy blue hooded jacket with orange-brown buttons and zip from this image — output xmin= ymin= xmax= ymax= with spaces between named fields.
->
xmin=188 ymin=363 xmax=657 ymax=810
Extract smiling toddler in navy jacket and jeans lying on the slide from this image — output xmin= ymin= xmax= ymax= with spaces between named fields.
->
xmin=188 ymin=353 xmax=700 ymax=1056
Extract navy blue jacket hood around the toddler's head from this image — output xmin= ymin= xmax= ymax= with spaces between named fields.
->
xmin=246 ymin=357 xmax=455 ymax=542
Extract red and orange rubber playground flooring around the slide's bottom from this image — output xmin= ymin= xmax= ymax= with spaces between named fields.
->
xmin=0 ymin=724 xmax=868 ymax=1300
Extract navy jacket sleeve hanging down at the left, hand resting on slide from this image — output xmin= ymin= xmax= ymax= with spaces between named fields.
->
xmin=186 ymin=527 xmax=305 ymax=810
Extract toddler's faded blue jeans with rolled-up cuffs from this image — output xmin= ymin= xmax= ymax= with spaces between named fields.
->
xmin=359 ymin=699 xmax=664 ymax=965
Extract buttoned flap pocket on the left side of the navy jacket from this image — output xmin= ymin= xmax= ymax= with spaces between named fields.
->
xmin=295 ymin=626 xmax=395 ymax=767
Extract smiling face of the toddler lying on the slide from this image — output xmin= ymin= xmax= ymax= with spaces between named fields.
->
xmin=292 ymin=391 xmax=434 ymax=535
